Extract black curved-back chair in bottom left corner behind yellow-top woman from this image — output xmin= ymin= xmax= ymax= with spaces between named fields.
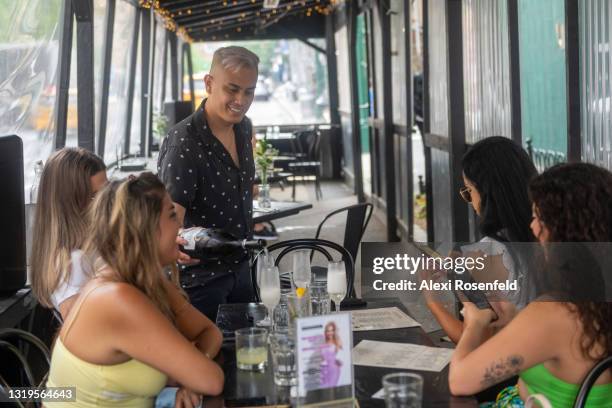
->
xmin=0 ymin=328 xmax=51 ymax=407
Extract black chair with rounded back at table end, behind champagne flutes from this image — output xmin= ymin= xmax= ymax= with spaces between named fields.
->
xmin=251 ymin=238 xmax=355 ymax=302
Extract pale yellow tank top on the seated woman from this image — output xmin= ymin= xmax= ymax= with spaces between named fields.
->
xmin=45 ymin=286 xmax=167 ymax=408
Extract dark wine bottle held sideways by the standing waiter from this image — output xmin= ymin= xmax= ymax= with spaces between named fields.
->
xmin=180 ymin=227 xmax=266 ymax=260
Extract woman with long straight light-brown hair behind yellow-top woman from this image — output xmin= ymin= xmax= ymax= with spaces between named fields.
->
xmin=31 ymin=148 xmax=107 ymax=319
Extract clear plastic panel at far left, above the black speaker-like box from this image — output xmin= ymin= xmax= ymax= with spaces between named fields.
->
xmin=0 ymin=0 xmax=63 ymax=192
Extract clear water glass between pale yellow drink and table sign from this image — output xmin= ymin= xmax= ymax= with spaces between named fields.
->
xmin=268 ymin=330 xmax=297 ymax=386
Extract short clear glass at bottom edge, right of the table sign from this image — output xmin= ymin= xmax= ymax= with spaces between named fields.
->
xmin=382 ymin=373 xmax=423 ymax=408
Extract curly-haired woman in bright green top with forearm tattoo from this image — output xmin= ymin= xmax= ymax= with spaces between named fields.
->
xmin=449 ymin=163 xmax=612 ymax=408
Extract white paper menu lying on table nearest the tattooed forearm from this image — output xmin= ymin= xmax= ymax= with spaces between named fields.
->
xmin=353 ymin=340 xmax=453 ymax=372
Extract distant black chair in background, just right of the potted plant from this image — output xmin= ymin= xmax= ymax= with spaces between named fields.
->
xmin=289 ymin=128 xmax=323 ymax=200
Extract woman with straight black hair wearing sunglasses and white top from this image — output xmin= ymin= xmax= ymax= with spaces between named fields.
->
xmin=425 ymin=136 xmax=537 ymax=343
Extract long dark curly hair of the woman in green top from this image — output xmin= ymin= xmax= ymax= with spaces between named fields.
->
xmin=529 ymin=163 xmax=612 ymax=359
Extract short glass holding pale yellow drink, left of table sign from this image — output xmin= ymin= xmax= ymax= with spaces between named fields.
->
xmin=236 ymin=327 xmax=268 ymax=371
